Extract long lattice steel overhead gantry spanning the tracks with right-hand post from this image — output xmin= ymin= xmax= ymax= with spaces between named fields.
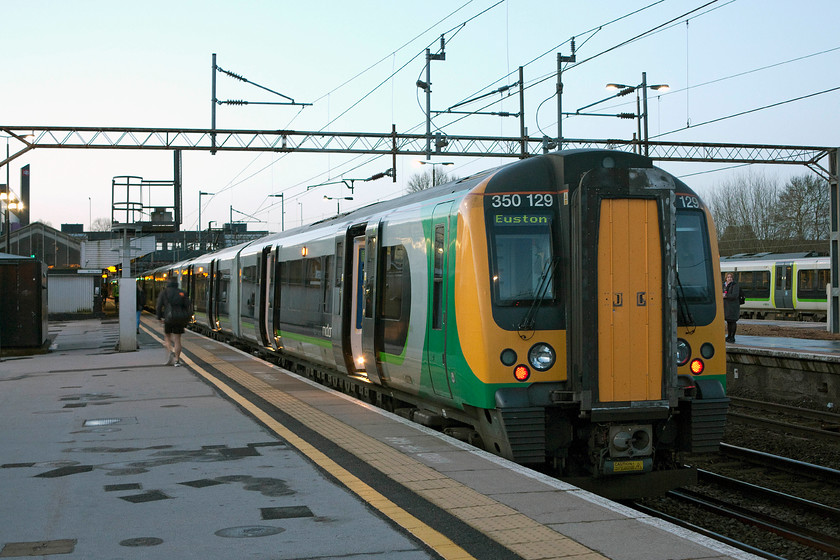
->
xmin=0 ymin=125 xmax=840 ymax=333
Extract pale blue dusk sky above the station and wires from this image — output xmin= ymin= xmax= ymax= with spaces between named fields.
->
xmin=0 ymin=0 xmax=840 ymax=231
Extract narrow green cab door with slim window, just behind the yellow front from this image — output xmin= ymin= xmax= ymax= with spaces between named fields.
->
xmin=426 ymin=202 xmax=452 ymax=397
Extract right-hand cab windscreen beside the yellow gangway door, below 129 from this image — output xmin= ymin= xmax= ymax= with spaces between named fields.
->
xmin=676 ymin=210 xmax=716 ymax=325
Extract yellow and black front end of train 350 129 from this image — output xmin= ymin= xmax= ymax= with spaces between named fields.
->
xmin=447 ymin=151 xmax=728 ymax=499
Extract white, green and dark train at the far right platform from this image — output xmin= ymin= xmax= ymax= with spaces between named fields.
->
xmin=720 ymin=253 xmax=831 ymax=321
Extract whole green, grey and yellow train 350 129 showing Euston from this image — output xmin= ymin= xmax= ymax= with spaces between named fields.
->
xmin=140 ymin=150 xmax=728 ymax=499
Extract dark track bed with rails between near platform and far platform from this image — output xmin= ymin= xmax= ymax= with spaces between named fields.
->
xmin=634 ymin=399 xmax=840 ymax=560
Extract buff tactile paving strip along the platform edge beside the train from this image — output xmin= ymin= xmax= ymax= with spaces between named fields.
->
xmin=184 ymin=337 xmax=605 ymax=560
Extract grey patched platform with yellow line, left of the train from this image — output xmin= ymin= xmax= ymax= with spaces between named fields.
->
xmin=0 ymin=316 xmax=755 ymax=560
